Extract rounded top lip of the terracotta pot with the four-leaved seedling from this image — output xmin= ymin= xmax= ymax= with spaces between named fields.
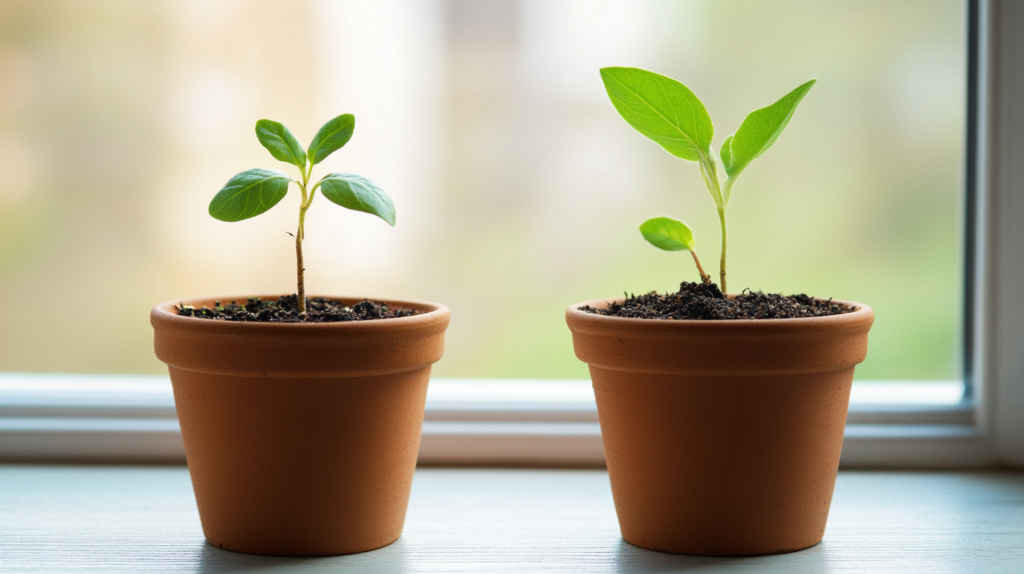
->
xmin=150 ymin=295 xmax=451 ymax=336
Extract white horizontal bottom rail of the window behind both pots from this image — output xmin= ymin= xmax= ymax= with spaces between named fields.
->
xmin=0 ymin=373 xmax=992 ymax=468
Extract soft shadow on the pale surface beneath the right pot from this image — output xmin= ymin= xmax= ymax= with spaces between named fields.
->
xmin=615 ymin=540 xmax=829 ymax=574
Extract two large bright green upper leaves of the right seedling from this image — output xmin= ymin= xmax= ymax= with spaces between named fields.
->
xmin=601 ymin=68 xmax=817 ymax=177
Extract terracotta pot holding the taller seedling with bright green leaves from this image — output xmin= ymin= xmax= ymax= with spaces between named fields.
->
xmin=565 ymin=300 xmax=874 ymax=556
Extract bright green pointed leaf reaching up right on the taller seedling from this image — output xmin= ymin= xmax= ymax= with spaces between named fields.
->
xmin=721 ymin=79 xmax=817 ymax=177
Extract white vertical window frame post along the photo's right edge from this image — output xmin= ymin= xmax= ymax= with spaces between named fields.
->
xmin=979 ymin=0 xmax=1024 ymax=467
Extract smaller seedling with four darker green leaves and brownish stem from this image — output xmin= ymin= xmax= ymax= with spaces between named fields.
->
xmin=210 ymin=114 xmax=394 ymax=317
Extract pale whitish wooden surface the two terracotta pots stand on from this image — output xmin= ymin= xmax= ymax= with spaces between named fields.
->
xmin=0 ymin=465 xmax=1024 ymax=574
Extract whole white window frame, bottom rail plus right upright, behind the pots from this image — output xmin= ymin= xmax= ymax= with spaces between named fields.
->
xmin=0 ymin=0 xmax=1024 ymax=469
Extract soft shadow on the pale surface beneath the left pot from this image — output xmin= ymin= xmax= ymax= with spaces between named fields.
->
xmin=195 ymin=540 xmax=408 ymax=574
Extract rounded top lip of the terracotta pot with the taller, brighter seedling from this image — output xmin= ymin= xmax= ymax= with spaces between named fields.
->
xmin=565 ymin=294 xmax=874 ymax=333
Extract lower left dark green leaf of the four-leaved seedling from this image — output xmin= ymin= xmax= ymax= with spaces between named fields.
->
xmin=210 ymin=169 xmax=291 ymax=221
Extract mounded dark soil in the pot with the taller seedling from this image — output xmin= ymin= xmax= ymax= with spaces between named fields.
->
xmin=581 ymin=282 xmax=856 ymax=320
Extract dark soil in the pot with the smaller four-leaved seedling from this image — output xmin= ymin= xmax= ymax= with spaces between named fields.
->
xmin=175 ymin=295 xmax=420 ymax=323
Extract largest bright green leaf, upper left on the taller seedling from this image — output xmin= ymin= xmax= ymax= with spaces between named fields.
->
xmin=601 ymin=68 xmax=715 ymax=162
